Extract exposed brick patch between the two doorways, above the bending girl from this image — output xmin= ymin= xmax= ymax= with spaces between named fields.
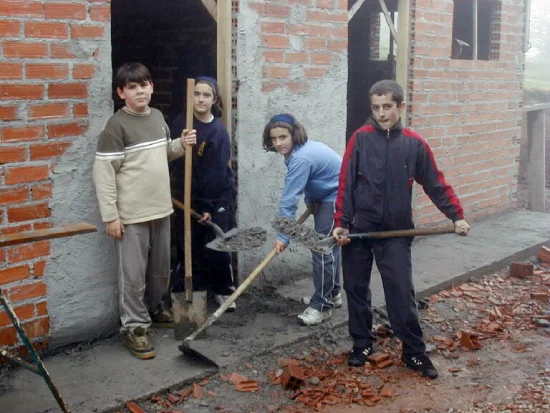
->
xmin=249 ymin=0 xmax=348 ymax=93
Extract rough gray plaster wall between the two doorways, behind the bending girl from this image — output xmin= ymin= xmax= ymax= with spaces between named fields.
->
xmin=235 ymin=0 xmax=348 ymax=288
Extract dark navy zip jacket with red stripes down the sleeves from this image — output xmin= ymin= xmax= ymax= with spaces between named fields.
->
xmin=335 ymin=121 xmax=464 ymax=232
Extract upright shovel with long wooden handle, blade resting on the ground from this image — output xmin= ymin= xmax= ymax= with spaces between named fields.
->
xmin=172 ymin=79 xmax=207 ymax=339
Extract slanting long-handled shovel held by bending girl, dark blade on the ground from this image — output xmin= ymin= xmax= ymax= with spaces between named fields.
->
xmin=178 ymin=208 xmax=312 ymax=366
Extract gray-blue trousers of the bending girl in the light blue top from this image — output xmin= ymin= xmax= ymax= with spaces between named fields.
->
xmin=309 ymin=202 xmax=341 ymax=311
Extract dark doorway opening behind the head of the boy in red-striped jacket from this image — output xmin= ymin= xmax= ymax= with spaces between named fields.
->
xmin=346 ymin=0 xmax=398 ymax=142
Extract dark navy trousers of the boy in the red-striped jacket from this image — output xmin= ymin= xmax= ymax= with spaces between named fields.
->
xmin=342 ymin=238 xmax=426 ymax=356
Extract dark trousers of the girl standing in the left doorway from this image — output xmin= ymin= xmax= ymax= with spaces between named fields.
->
xmin=171 ymin=191 xmax=235 ymax=295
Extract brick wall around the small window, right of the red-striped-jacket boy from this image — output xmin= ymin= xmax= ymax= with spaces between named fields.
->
xmin=408 ymin=0 xmax=524 ymax=224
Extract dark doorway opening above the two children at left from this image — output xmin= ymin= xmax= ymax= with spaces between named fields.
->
xmin=111 ymin=0 xmax=216 ymax=125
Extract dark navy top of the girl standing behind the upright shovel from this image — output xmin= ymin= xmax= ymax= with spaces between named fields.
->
xmin=170 ymin=114 xmax=233 ymax=214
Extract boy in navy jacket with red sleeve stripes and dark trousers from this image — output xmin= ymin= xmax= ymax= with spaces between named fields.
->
xmin=333 ymin=80 xmax=470 ymax=378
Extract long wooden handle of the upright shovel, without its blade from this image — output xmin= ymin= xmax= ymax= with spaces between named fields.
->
xmin=182 ymin=79 xmax=195 ymax=302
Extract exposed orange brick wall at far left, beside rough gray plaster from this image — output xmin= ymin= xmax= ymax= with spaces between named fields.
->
xmin=0 ymin=0 xmax=110 ymax=346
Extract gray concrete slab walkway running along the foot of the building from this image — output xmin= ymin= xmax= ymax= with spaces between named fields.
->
xmin=0 ymin=210 xmax=550 ymax=413
